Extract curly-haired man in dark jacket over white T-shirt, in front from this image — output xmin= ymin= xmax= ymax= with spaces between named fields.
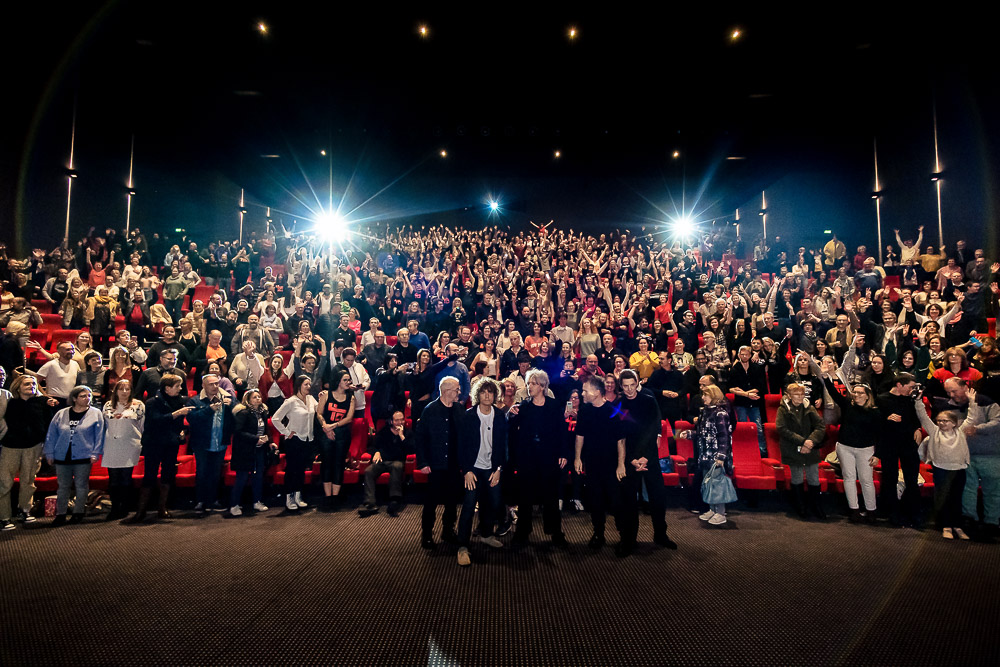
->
xmin=458 ymin=376 xmax=507 ymax=566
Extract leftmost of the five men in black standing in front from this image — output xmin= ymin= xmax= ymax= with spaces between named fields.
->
xmin=415 ymin=376 xmax=462 ymax=549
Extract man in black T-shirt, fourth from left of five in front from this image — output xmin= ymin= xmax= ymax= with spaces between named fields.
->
xmin=573 ymin=376 xmax=627 ymax=556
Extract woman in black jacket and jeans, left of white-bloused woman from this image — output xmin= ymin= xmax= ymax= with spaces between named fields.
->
xmin=229 ymin=389 xmax=278 ymax=516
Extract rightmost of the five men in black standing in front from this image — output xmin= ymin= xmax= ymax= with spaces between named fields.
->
xmin=619 ymin=368 xmax=677 ymax=556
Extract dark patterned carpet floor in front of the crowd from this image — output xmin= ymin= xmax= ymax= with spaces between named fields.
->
xmin=0 ymin=494 xmax=1000 ymax=666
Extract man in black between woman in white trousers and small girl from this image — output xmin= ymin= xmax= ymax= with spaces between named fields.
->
xmin=875 ymin=373 xmax=923 ymax=527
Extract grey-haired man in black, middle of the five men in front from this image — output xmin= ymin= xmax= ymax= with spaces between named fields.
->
xmin=508 ymin=369 xmax=572 ymax=547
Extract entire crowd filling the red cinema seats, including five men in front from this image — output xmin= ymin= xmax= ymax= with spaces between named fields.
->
xmin=0 ymin=224 xmax=1000 ymax=565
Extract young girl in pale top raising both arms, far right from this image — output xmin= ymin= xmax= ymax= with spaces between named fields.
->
xmin=913 ymin=387 xmax=984 ymax=540
